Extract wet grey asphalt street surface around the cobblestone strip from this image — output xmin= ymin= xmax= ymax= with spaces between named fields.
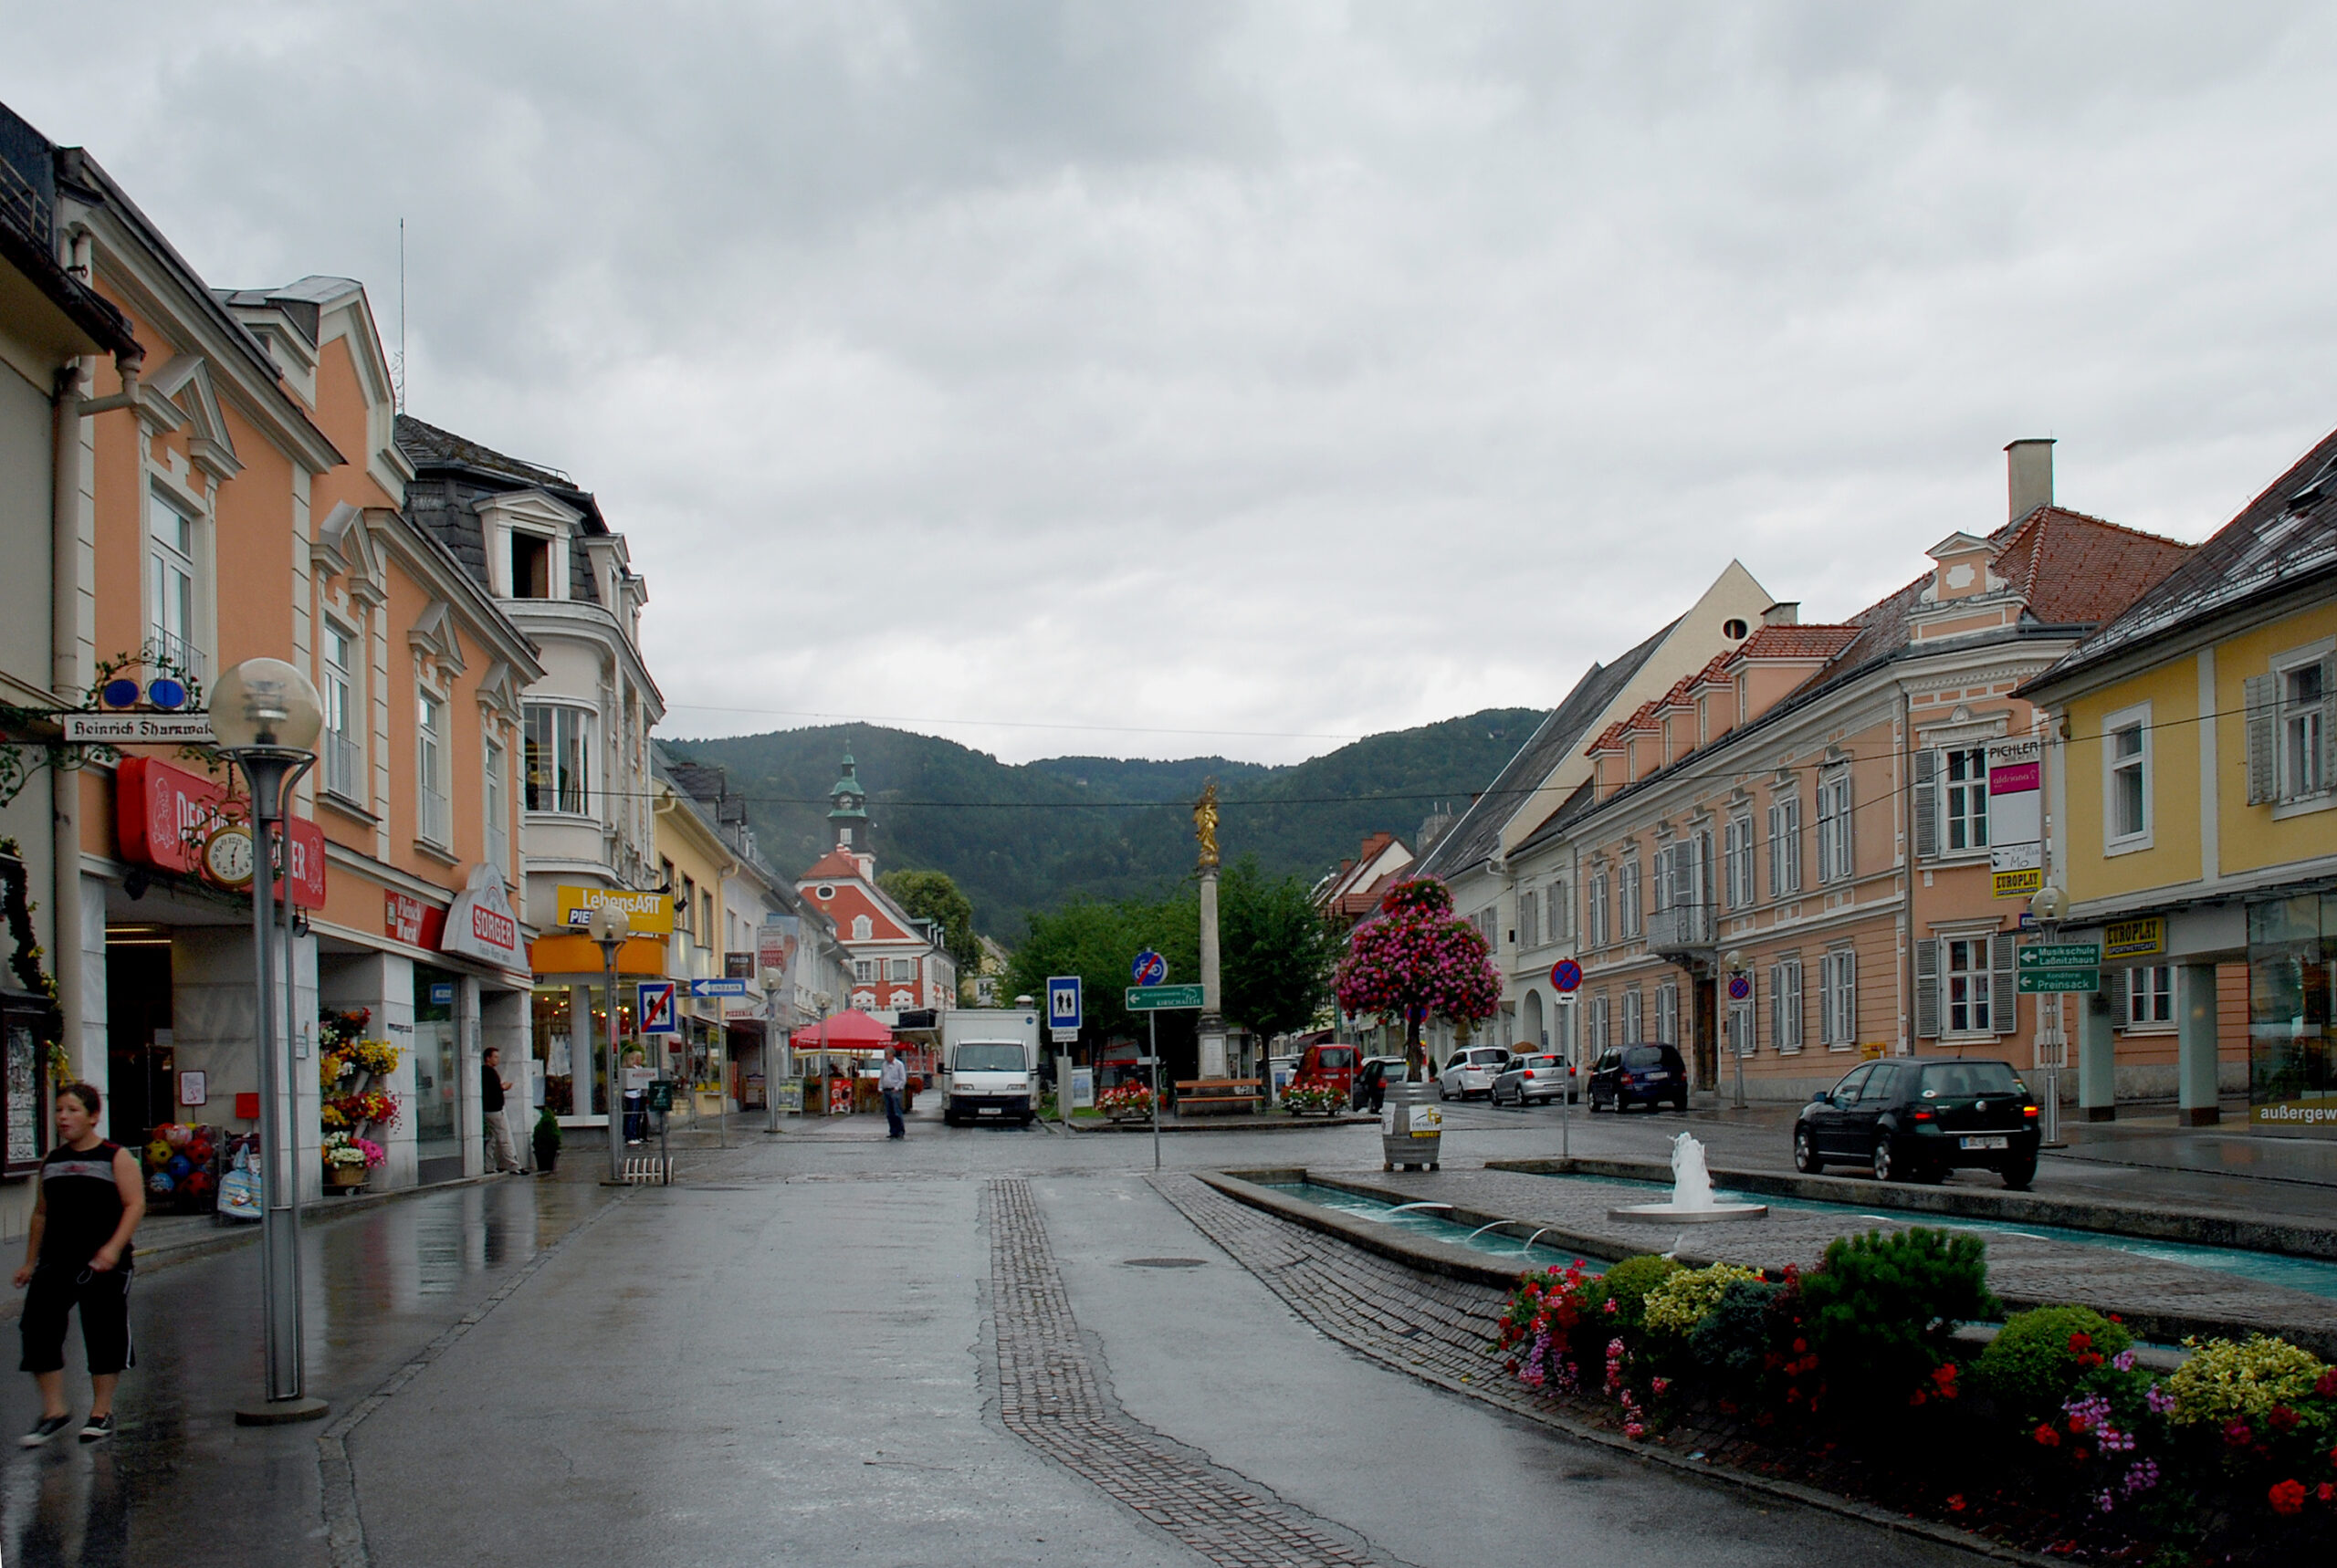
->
xmin=0 ymin=1105 xmax=2300 ymax=1568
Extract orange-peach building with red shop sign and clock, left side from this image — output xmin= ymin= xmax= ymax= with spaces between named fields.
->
xmin=26 ymin=113 xmax=540 ymax=1189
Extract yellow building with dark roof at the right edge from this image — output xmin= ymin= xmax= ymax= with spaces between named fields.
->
xmin=2021 ymin=434 xmax=2337 ymax=1135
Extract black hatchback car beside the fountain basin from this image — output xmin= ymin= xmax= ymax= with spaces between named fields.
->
xmin=1793 ymin=1056 xmax=2040 ymax=1192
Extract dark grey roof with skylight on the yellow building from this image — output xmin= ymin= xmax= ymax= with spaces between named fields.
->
xmin=2031 ymin=430 xmax=2337 ymax=687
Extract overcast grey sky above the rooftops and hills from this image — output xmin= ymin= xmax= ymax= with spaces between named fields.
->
xmin=18 ymin=0 xmax=2337 ymax=762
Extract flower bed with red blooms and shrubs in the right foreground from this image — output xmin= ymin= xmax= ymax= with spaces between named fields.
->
xmin=1495 ymin=1229 xmax=2337 ymax=1565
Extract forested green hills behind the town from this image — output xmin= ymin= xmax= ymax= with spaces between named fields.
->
xmin=664 ymin=708 xmax=1543 ymax=944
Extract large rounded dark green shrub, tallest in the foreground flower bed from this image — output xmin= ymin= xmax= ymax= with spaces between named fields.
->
xmin=1797 ymin=1227 xmax=1996 ymax=1406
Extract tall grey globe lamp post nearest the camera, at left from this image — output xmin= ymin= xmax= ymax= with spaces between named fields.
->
xmin=210 ymin=659 xmax=330 ymax=1426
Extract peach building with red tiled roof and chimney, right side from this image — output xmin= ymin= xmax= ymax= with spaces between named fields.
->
xmin=1542 ymin=442 xmax=2187 ymax=1101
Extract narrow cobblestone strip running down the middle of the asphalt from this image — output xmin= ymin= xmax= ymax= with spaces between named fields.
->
xmin=986 ymin=1177 xmax=1390 ymax=1568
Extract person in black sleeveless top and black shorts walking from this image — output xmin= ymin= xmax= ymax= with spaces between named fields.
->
xmin=16 ymin=1084 xmax=145 ymax=1448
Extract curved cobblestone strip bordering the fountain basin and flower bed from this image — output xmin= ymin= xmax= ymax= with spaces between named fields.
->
xmin=1148 ymin=1176 xmax=2052 ymax=1568
